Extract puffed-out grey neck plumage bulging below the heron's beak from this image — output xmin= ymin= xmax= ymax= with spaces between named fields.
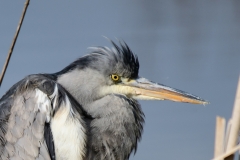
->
xmin=85 ymin=94 xmax=144 ymax=159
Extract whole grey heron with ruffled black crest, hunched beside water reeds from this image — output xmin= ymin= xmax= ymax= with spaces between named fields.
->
xmin=0 ymin=41 xmax=207 ymax=160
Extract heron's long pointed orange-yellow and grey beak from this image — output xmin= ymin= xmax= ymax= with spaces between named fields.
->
xmin=124 ymin=78 xmax=208 ymax=105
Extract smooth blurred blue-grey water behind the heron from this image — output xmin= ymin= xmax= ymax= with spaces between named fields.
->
xmin=0 ymin=0 xmax=240 ymax=160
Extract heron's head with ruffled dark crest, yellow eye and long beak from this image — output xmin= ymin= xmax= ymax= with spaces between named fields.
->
xmin=56 ymin=42 xmax=207 ymax=104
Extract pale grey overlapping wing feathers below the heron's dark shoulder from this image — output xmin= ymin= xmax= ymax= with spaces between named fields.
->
xmin=0 ymin=77 xmax=51 ymax=160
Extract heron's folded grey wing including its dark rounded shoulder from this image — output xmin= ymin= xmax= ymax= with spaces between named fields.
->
xmin=0 ymin=75 xmax=86 ymax=160
